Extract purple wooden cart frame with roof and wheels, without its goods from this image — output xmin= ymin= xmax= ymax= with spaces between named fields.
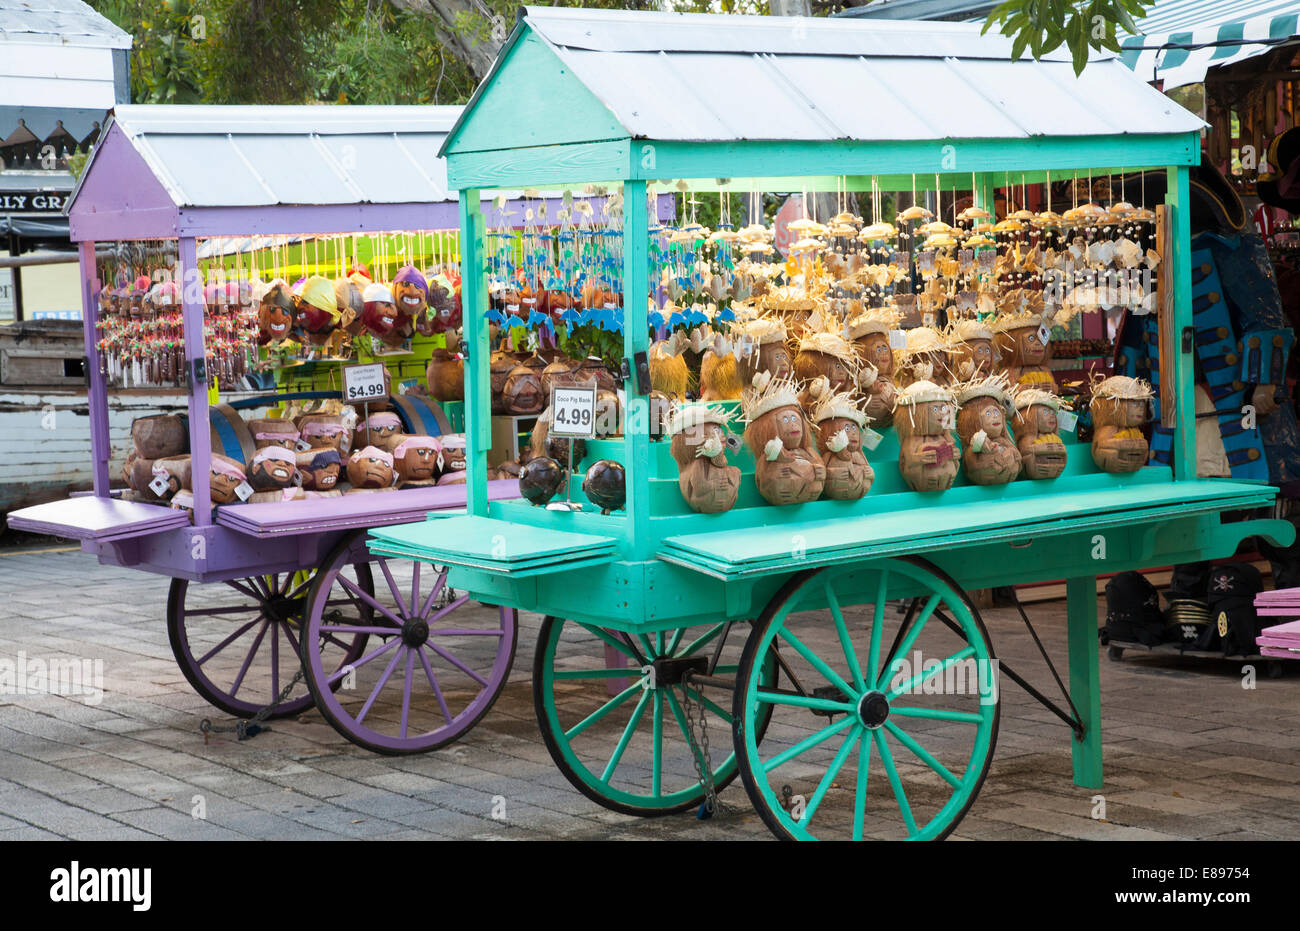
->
xmin=9 ymin=107 xmax=523 ymax=754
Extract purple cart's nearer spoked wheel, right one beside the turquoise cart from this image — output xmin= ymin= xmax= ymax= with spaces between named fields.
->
xmin=303 ymin=537 xmax=517 ymax=755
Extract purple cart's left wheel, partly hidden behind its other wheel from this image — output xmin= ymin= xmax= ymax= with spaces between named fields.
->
xmin=166 ymin=563 xmax=373 ymax=718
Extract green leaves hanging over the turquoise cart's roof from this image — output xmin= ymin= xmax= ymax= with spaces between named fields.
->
xmin=983 ymin=0 xmax=1154 ymax=74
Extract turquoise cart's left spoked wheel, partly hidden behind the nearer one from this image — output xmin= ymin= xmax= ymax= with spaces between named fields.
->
xmin=533 ymin=618 xmax=775 ymax=817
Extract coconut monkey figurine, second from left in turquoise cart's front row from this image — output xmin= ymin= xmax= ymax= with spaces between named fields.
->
xmin=741 ymin=372 xmax=826 ymax=505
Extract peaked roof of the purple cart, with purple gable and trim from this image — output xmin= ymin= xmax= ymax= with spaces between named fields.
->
xmin=68 ymin=105 xmax=478 ymax=241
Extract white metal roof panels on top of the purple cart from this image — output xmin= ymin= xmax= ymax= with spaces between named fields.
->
xmin=104 ymin=107 xmax=460 ymax=207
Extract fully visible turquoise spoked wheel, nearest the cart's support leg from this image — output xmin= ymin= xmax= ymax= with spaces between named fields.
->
xmin=732 ymin=558 xmax=1000 ymax=840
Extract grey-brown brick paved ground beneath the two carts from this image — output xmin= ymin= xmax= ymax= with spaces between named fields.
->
xmin=0 ymin=550 xmax=1300 ymax=841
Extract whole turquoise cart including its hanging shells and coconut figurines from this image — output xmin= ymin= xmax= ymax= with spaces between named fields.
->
xmin=369 ymin=7 xmax=1294 ymax=839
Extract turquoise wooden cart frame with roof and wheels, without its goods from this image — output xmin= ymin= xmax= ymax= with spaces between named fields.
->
xmin=369 ymin=8 xmax=1294 ymax=839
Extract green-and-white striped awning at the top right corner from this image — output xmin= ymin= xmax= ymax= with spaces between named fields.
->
xmin=1121 ymin=0 xmax=1300 ymax=91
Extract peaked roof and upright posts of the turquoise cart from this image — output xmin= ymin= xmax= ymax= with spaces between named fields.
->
xmin=431 ymin=8 xmax=1204 ymax=558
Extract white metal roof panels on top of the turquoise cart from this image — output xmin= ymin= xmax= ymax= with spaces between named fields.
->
xmin=524 ymin=7 xmax=1204 ymax=142
